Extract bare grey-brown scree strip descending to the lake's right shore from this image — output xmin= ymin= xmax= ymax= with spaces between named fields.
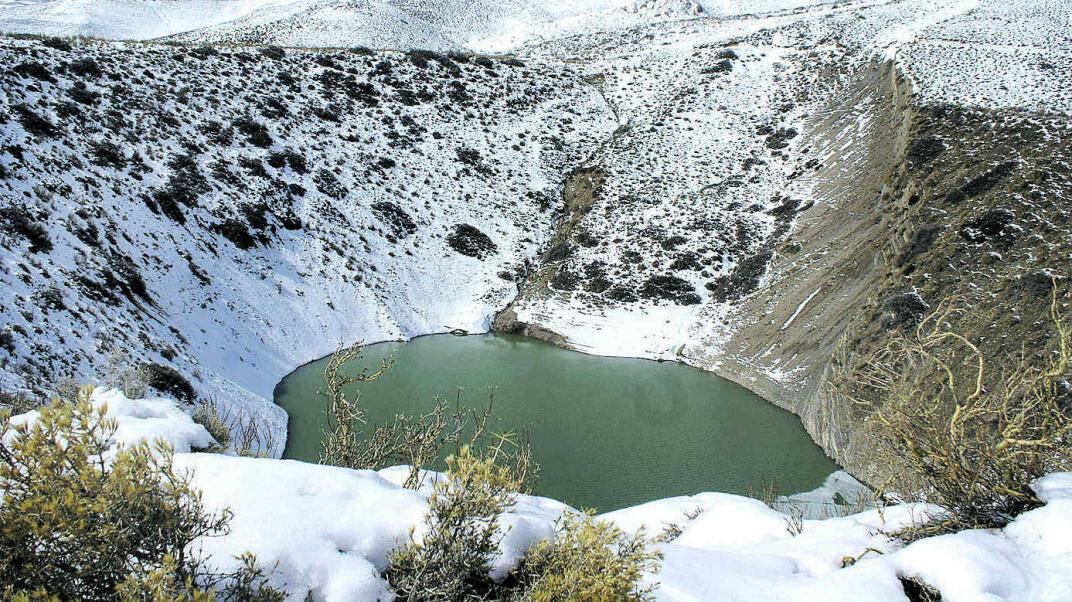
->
xmin=690 ymin=57 xmax=913 ymax=473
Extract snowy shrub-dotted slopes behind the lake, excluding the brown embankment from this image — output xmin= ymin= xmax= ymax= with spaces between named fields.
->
xmin=0 ymin=0 xmax=1072 ymax=449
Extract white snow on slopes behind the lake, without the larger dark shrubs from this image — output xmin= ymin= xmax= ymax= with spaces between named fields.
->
xmin=0 ymin=0 xmax=1072 ymax=452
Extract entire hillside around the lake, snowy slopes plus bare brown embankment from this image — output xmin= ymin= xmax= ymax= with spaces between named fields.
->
xmin=0 ymin=0 xmax=1072 ymax=478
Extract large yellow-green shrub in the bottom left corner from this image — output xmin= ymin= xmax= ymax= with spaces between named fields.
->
xmin=0 ymin=390 xmax=229 ymax=600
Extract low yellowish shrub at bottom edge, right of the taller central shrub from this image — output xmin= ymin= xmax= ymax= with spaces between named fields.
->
xmin=512 ymin=513 xmax=661 ymax=602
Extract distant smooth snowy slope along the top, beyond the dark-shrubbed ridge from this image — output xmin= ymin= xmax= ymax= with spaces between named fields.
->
xmin=0 ymin=0 xmax=861 ymax=51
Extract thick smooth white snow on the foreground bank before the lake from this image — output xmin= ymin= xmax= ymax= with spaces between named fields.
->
xmin=10 ymin=391 xmax=1072 ymax=602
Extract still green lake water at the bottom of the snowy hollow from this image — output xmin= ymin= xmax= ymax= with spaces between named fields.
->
xmin=276 ymin=335 xmax=837 ymax=511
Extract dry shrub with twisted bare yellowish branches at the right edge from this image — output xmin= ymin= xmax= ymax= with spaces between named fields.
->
xmin=843 ymin=287 xmax=1072 ymax=531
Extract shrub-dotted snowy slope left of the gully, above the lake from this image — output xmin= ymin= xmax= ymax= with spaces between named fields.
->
xmin=0 ymin=35 xmax=613 ymax=442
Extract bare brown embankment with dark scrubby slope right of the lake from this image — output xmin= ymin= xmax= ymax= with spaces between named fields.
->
xmin=694 ymin=56 xmax=1072 ymax=481
